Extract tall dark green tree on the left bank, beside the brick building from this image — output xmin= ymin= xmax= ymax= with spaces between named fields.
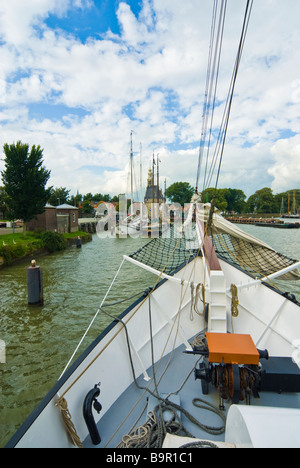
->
xmin=1 ymin=141 xmax=51 ymax=234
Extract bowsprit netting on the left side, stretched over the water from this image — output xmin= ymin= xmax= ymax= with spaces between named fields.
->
xmin=130 ymin=235 xmax=199 ymax=275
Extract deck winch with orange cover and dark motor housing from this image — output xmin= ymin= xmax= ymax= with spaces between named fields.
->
xmin=193 ymin=333 xmax=300 ymax=406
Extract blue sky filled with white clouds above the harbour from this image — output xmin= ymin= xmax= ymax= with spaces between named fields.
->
xmin=0 ymin=0 xmax=300 ymax=196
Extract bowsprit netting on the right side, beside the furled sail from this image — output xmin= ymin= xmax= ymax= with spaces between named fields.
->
xmin=212 ymin=233 xmax=300 ymax=280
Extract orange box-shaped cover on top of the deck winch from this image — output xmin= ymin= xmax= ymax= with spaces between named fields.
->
xmin=206 ymin=333 xmax=259 ymax=366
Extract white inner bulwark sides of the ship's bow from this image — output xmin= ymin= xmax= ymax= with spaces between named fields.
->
xmin=8 ymin=247 xmax=300 ymax=448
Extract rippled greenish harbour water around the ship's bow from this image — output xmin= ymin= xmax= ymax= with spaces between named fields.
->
xmin=0 ymin=225 xmax=300 ymax=447
